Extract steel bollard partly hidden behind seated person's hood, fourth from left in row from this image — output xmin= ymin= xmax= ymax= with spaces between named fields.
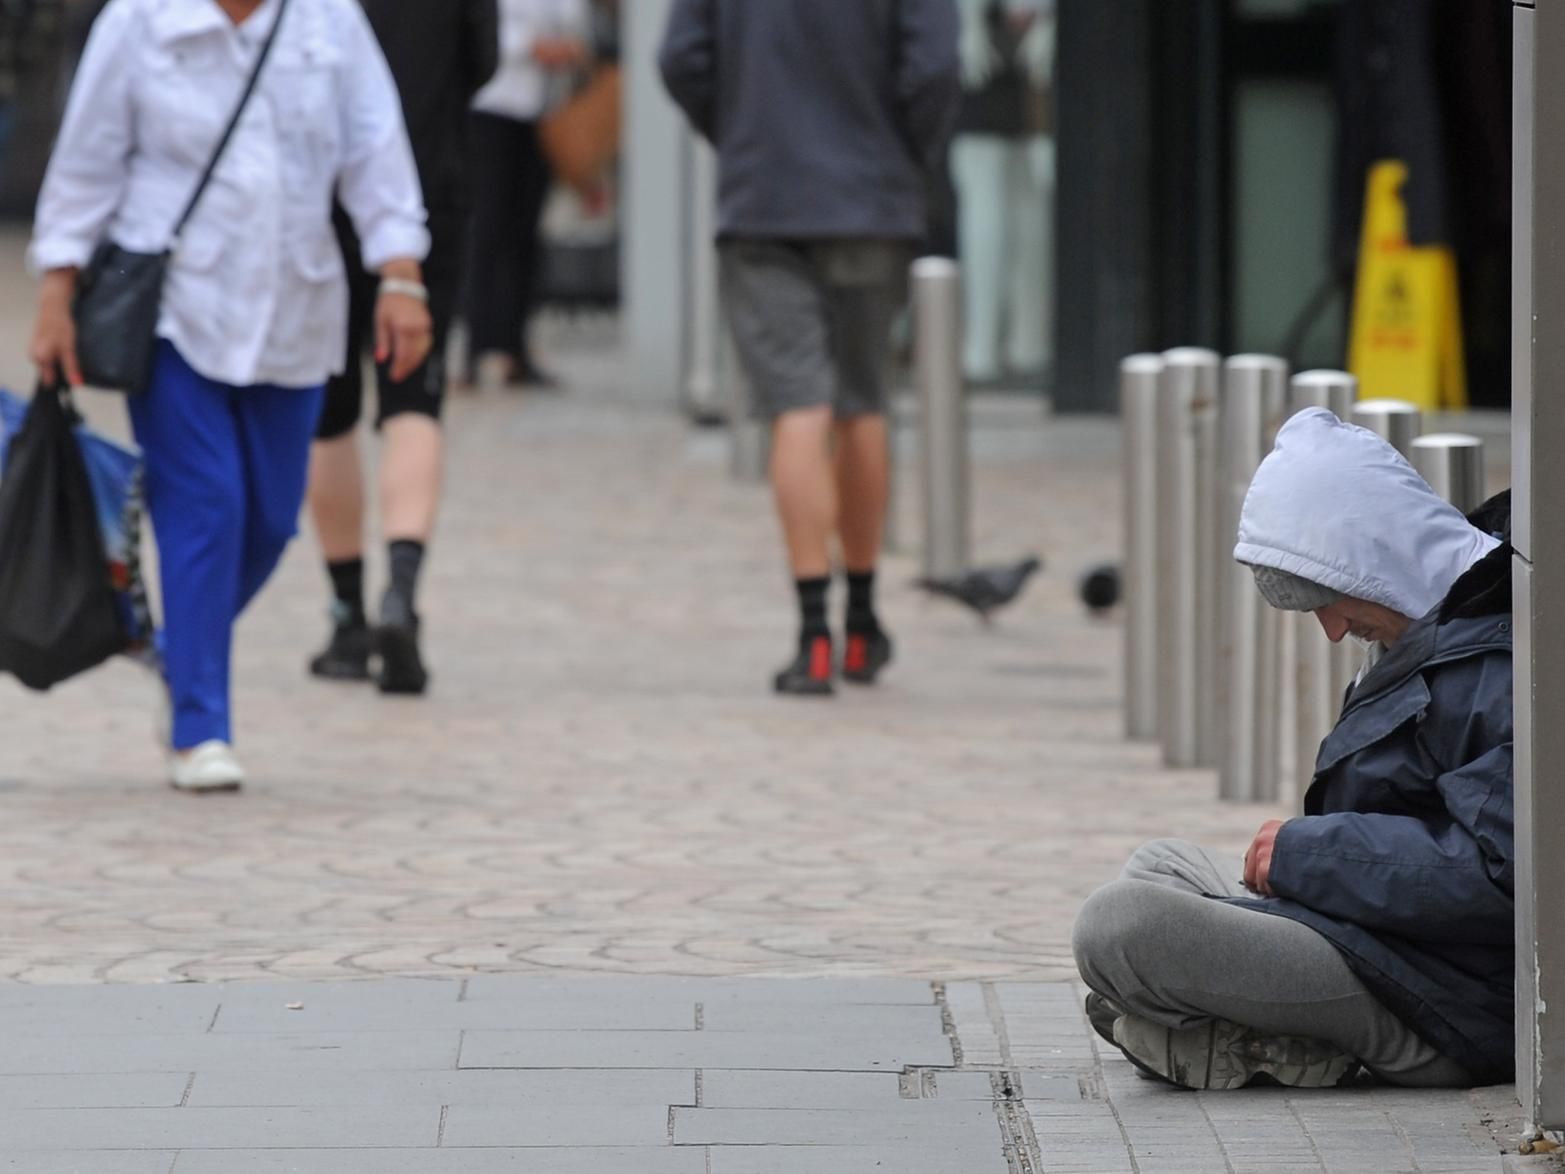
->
xmin=1288 ymin=371 xmax=1360 ymax=800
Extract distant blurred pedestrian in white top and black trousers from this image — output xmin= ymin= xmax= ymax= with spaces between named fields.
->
xmin=465 ymin=0 xmax=592 ymax=396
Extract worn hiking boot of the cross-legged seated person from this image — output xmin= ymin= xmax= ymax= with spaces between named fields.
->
xmin=1114 ymin=1014 xmax=1358 ymax=1089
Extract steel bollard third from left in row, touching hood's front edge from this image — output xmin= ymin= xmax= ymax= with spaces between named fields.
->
xmin=1214 ymin=355 xmax=1288 ymax=800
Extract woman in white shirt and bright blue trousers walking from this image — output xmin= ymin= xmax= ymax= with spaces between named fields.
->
xmin=30 ymin=0 xmax=430 ymax=790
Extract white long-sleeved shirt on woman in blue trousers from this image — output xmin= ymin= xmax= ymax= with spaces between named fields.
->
xmin=30 ymin=0 xmax=429 ymax=387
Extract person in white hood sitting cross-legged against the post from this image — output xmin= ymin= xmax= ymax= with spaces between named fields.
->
xmin=1074 ymin=409 xmax=1513 ymax=1088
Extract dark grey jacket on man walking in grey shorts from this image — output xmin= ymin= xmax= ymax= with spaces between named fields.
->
xmin=660 ymin=0 xmax=961 ymax=239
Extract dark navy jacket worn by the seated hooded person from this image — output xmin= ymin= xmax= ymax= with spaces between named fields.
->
xmin=1236 ymin=499 xmax=1515 ymax=1083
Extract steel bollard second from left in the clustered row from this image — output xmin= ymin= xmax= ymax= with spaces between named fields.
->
xmin=1157 ymin=348 xmax=1221 ymax=767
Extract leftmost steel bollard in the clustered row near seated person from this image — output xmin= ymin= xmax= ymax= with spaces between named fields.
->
xmin=1119 ymin=355 xmax=1163 ymax=740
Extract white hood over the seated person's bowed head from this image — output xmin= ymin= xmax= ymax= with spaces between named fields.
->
xmin=1233 ymin=407 xmax=1499 ymax=620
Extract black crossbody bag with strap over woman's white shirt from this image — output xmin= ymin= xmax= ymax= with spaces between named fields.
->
xmin=70 ymin=0 xmax=288 ymax=394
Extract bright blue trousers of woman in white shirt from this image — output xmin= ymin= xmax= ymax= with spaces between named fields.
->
xmin=130 ymin=341 xmax=321 ymax=750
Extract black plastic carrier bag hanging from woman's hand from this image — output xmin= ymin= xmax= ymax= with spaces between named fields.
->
xmin=0 ymin=388 xmax=130 ymax=689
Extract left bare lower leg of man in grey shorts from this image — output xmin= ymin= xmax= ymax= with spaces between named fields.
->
xmin=772 ymin=405 xmax=837 ymax=579
